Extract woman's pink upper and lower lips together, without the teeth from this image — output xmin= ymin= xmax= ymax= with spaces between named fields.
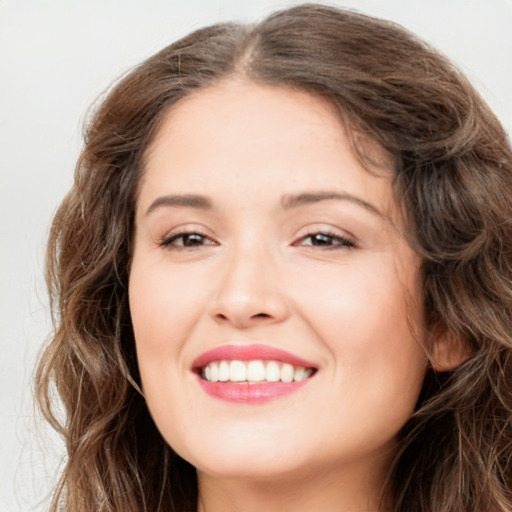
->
xmin=192 ymin=345 xmax=316 ymax=404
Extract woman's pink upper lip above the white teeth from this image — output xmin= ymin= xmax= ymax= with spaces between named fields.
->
xmin=192 ymin=344 xmax=316 ymax=369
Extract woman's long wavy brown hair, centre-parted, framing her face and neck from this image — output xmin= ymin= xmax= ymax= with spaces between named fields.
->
xmin=36 ymin=4 xmax=512 ymax=512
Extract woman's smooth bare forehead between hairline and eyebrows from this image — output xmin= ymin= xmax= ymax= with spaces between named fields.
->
xmin=139 ymin=80 xmax=393 ymax=218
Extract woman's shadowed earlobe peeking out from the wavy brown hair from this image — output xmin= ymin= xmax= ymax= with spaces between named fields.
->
xmin=430 ymin=327 xmax=471 ymax=372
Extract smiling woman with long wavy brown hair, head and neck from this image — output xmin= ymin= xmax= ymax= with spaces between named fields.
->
xmin=37 ymin=5 xmax=512 ymax=512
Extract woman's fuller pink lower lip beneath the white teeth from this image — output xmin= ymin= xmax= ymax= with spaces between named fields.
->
xmin=198 ymin=377 xmax=309 ymax=404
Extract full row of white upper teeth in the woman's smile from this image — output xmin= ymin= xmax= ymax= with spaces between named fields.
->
xmin=202 ymin=360 xmax=313 ymax=382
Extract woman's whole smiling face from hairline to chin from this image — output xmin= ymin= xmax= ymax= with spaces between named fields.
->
xmin=129 ymin=81 xmax=426 ymax=480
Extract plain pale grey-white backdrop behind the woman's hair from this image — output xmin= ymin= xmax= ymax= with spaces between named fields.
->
xmin=0 ymin=0 xmax=512 ymax=512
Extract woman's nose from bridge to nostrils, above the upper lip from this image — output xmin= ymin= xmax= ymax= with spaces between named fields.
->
xmin=210 ymin=240 xmax=289 ymax=329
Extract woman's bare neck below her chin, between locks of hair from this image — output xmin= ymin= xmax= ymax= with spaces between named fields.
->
xmin=198 ymin=460 xmax=388 ymax=512
